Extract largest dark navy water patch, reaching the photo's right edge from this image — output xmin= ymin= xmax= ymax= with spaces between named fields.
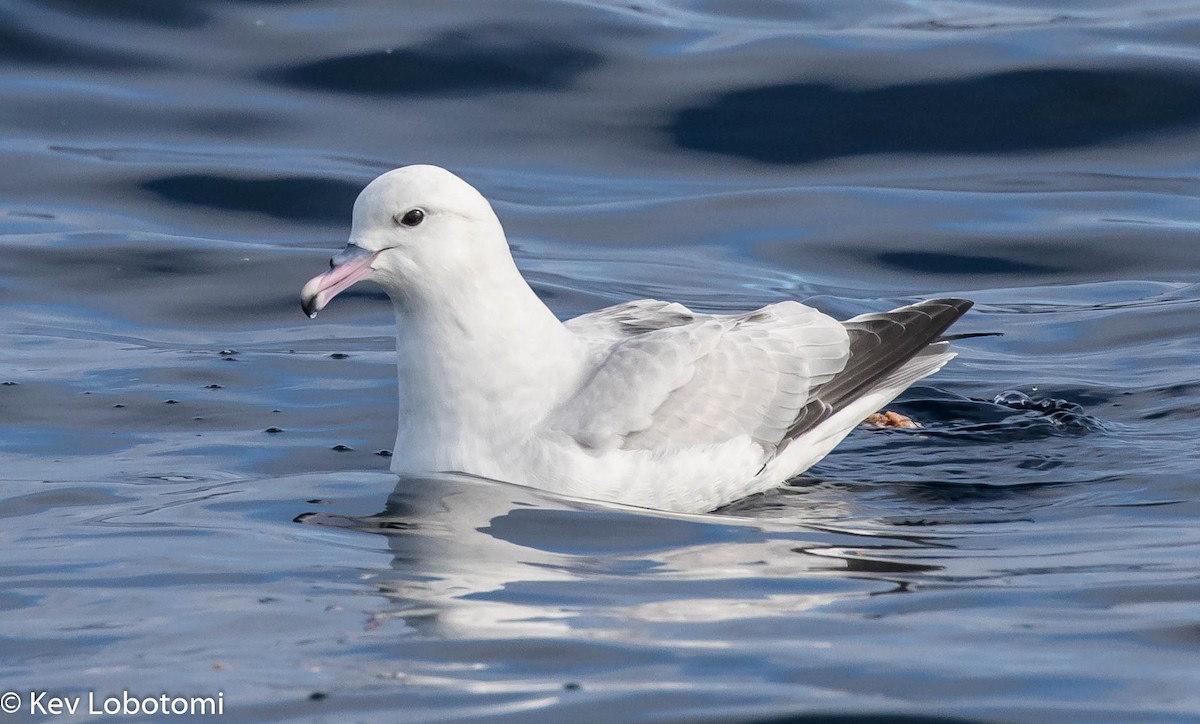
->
xmin=666 ymin=68 xmax=1200 ymax=163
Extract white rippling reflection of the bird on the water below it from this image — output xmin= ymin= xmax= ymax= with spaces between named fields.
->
xmin=301 ymin=474 xmax=941 ymax=639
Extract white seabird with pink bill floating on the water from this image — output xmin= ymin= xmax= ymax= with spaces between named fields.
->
xmin=301 ymin=166 xmax=971 ymax=513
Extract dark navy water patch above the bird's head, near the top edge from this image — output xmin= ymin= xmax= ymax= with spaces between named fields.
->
xmin=274 ymin=26 xmax=602 ymax=96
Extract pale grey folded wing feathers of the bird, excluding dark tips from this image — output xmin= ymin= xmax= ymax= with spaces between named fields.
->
xmin=552 ymin=300 xmax=850 ymax=451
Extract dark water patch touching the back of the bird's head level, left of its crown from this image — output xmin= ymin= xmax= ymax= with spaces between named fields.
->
xmin=140 ymin=174 xmax=362 ymax=222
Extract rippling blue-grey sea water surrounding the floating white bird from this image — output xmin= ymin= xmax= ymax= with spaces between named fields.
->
xmin=0 ymin=0 xmax=1200 ymax=722
